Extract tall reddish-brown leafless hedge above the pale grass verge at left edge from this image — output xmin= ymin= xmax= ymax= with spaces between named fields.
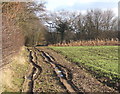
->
xmin=0 ymin=3 xmax=24 ymax=66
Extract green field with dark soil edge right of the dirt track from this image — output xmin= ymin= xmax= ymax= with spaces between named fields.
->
xmin=50 ymin=46 xmax=120 ymax=88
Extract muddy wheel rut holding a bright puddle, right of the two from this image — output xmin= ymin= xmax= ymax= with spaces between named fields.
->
xmin=35 ymin=48 xmax=83 ymax=94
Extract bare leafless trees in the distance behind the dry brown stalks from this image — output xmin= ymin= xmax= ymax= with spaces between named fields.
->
xmin=43 ymin=9 xmax=118 ymax=44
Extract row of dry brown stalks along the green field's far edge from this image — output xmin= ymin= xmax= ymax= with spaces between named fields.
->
xmin=49 ymin=39 xmax=120 ymax=46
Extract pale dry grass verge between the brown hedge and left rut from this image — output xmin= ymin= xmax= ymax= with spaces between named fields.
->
xmin=0 ymin=47 xmax=28 ymax=93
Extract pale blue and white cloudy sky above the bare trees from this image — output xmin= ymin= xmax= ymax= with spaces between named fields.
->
xmin=45 ymin=0 xmax=119 ymax=15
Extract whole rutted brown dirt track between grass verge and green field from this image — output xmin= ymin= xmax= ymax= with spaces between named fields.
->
xmin=24 ymin=47 xmax=116 ymax=94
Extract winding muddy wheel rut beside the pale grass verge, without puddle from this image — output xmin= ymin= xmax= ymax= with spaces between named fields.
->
xmin=22 ymin=49 xmax=42 ymax=94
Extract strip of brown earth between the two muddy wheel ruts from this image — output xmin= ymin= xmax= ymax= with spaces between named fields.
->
xmin=23 ymin=49 xmax=67 ymax=92
